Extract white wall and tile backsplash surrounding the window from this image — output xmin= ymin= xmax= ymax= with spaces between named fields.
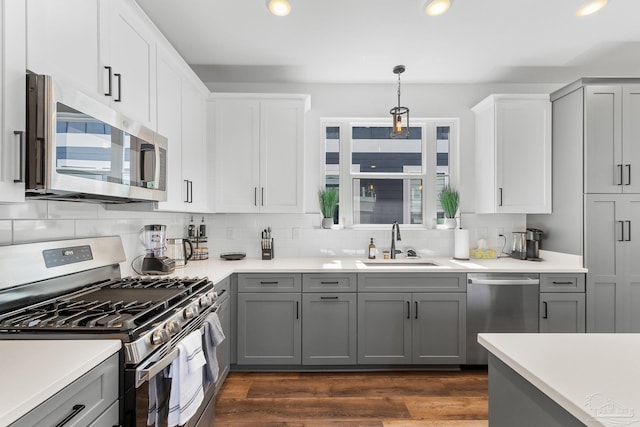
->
xmin=0 ymin=79 xmax=560 ymax=274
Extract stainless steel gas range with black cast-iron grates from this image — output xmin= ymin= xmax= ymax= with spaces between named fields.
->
xmin=0 ymin=237 xmax=227 ymax=426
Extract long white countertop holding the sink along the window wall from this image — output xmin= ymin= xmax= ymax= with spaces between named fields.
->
xmin=172 ymin=251 xmax=587 ymax=282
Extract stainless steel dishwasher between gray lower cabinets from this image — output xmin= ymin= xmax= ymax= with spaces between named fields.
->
xmin=467 ymin=273 xmax=540 ymax=365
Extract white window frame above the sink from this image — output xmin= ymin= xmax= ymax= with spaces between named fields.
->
xmin=320 ymin=117 xmax=460 ymax=230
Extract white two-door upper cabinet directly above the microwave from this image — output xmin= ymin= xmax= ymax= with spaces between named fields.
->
xmin=27 ymin=0 xmax=156 ymax=129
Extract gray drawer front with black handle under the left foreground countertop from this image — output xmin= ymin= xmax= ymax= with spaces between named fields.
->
xmin=11 ymin=353 xmax=119 ymax=427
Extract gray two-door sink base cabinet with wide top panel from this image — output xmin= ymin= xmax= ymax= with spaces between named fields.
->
xmin=358 ymin=274 xmax=467 ymax=365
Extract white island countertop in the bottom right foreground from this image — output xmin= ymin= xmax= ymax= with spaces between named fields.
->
xmin=478 ymin=334 xmax=640 ymax=426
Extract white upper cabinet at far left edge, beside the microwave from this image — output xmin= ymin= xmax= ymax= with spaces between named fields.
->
xmin=0 ymin=0 xmax=26 ymax=202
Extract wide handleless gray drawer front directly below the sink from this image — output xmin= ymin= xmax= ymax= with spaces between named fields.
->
xmin=358 ymin=273 xmax=467 ymax=292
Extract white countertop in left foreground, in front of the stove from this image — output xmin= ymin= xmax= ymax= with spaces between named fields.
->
xmin=0 ymin=340 xmax=121 ymax=426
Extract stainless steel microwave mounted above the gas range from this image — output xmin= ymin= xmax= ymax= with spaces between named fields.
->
xmin=24 ymin=73 xmax=167 ymax=203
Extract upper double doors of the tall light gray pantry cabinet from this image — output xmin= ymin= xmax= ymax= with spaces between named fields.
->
xmin=584 ymin=84 xmax=640 ymax=193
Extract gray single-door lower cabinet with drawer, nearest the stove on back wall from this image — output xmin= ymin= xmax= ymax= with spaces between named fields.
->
xmin=236 ymin=274 xmax=302 ymax=365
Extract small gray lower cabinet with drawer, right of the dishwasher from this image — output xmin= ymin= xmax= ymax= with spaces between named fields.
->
xmin=538 ymin=273 xmax=586 ymax=333
